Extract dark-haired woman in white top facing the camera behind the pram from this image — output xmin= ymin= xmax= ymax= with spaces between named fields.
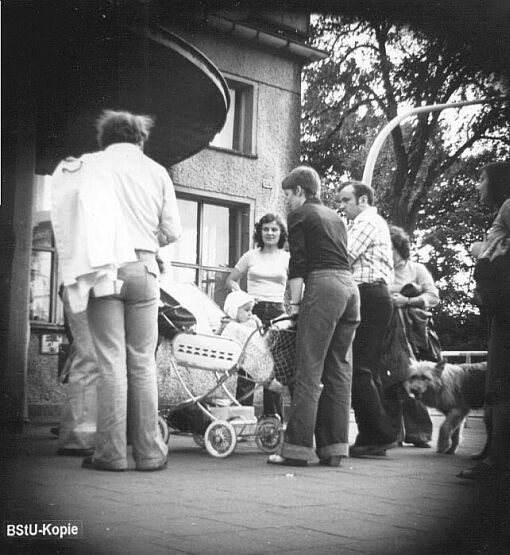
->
xmin=226 ymin=214 xmax=289 ymax=418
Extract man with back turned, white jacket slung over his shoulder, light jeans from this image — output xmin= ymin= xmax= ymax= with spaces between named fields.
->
xmin=53 ymin=110 xmax=181 ymax=471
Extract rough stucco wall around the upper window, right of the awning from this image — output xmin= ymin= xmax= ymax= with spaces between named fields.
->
xmin=171 ymin=28 xmax=301 ymax=224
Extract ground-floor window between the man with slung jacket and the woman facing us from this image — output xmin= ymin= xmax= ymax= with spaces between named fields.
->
xmin=162 ymin=195 xmax=249 ymax=306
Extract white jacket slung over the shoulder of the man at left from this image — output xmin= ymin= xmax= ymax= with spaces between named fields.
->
xmin=51 ymin=152 xmax=136 ymax=312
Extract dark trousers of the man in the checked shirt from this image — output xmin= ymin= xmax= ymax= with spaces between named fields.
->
xmin=352 ymin=283 xmax=400 ymax=445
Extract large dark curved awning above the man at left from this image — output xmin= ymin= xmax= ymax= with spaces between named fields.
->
xmin=34 ymin=14 xmax=230 ymax=173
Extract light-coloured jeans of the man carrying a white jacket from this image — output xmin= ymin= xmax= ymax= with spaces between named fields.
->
xmin=88 ymin=253 xmax=168 ymax=469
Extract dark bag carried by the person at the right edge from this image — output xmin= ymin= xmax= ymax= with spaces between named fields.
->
xmin=473 ymin=238 xmax=510 ymax=314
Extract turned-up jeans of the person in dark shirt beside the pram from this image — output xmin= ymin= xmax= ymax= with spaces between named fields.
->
xmin=281 ymin=270 xmax=360 ymax=460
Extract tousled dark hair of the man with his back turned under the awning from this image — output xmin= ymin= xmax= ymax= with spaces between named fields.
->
xmin=96 ymin=110 xmax=154 ymax=148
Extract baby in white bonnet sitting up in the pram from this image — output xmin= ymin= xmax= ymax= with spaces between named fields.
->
xmin=219 ymin=290 xmax=283 ymax=405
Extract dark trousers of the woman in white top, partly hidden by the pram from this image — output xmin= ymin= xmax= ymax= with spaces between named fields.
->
xmin=236 ymin=301 xmax=285 ymax=414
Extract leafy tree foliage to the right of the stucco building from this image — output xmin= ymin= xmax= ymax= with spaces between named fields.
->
xmin=302 ymin=16 xmax=510 ymax=349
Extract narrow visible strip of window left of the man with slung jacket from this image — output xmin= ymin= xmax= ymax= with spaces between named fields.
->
xmin=30 ymin=175 xmax=64 ymax=325
